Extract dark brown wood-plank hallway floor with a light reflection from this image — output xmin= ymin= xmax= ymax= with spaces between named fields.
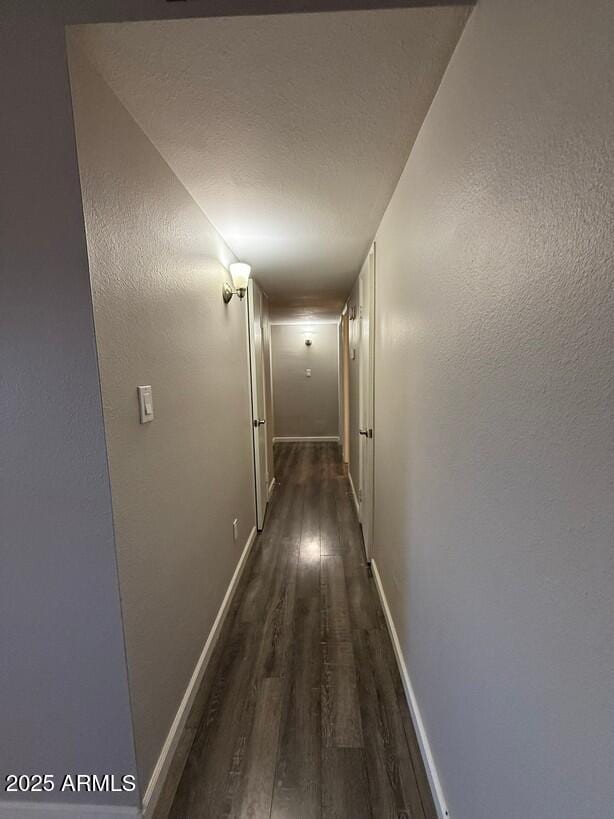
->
xmin=166 ymin=443 xmax=435 ymax=819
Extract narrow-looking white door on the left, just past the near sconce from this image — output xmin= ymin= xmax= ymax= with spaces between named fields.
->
xmin=247 ymin=279 xmax=269 ymax=530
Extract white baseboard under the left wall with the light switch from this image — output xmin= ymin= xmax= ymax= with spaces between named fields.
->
xmin=141 ymin=526 xmax=257 ymax=819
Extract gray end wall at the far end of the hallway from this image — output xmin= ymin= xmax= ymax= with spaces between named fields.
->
xmin=271 ymin=324 xmax=339 ymax=438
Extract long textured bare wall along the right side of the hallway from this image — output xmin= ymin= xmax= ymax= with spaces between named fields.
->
xmin=375 ymin=0 xmax=614 ymax=819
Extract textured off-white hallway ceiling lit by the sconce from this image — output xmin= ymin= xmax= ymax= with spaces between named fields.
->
xmin=72 ymin=6 xmax=468 ymax=318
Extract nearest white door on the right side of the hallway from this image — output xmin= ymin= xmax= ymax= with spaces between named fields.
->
xmin=359 ymin=244 xmax=375 ymax=559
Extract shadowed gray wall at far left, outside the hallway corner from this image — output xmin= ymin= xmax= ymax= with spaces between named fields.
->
xmin=0 ymin=9 xmax=138 ymax=804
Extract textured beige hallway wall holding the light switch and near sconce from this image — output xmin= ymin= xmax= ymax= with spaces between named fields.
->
xmin=70 ymin=43 xmax=255 ymax=788
